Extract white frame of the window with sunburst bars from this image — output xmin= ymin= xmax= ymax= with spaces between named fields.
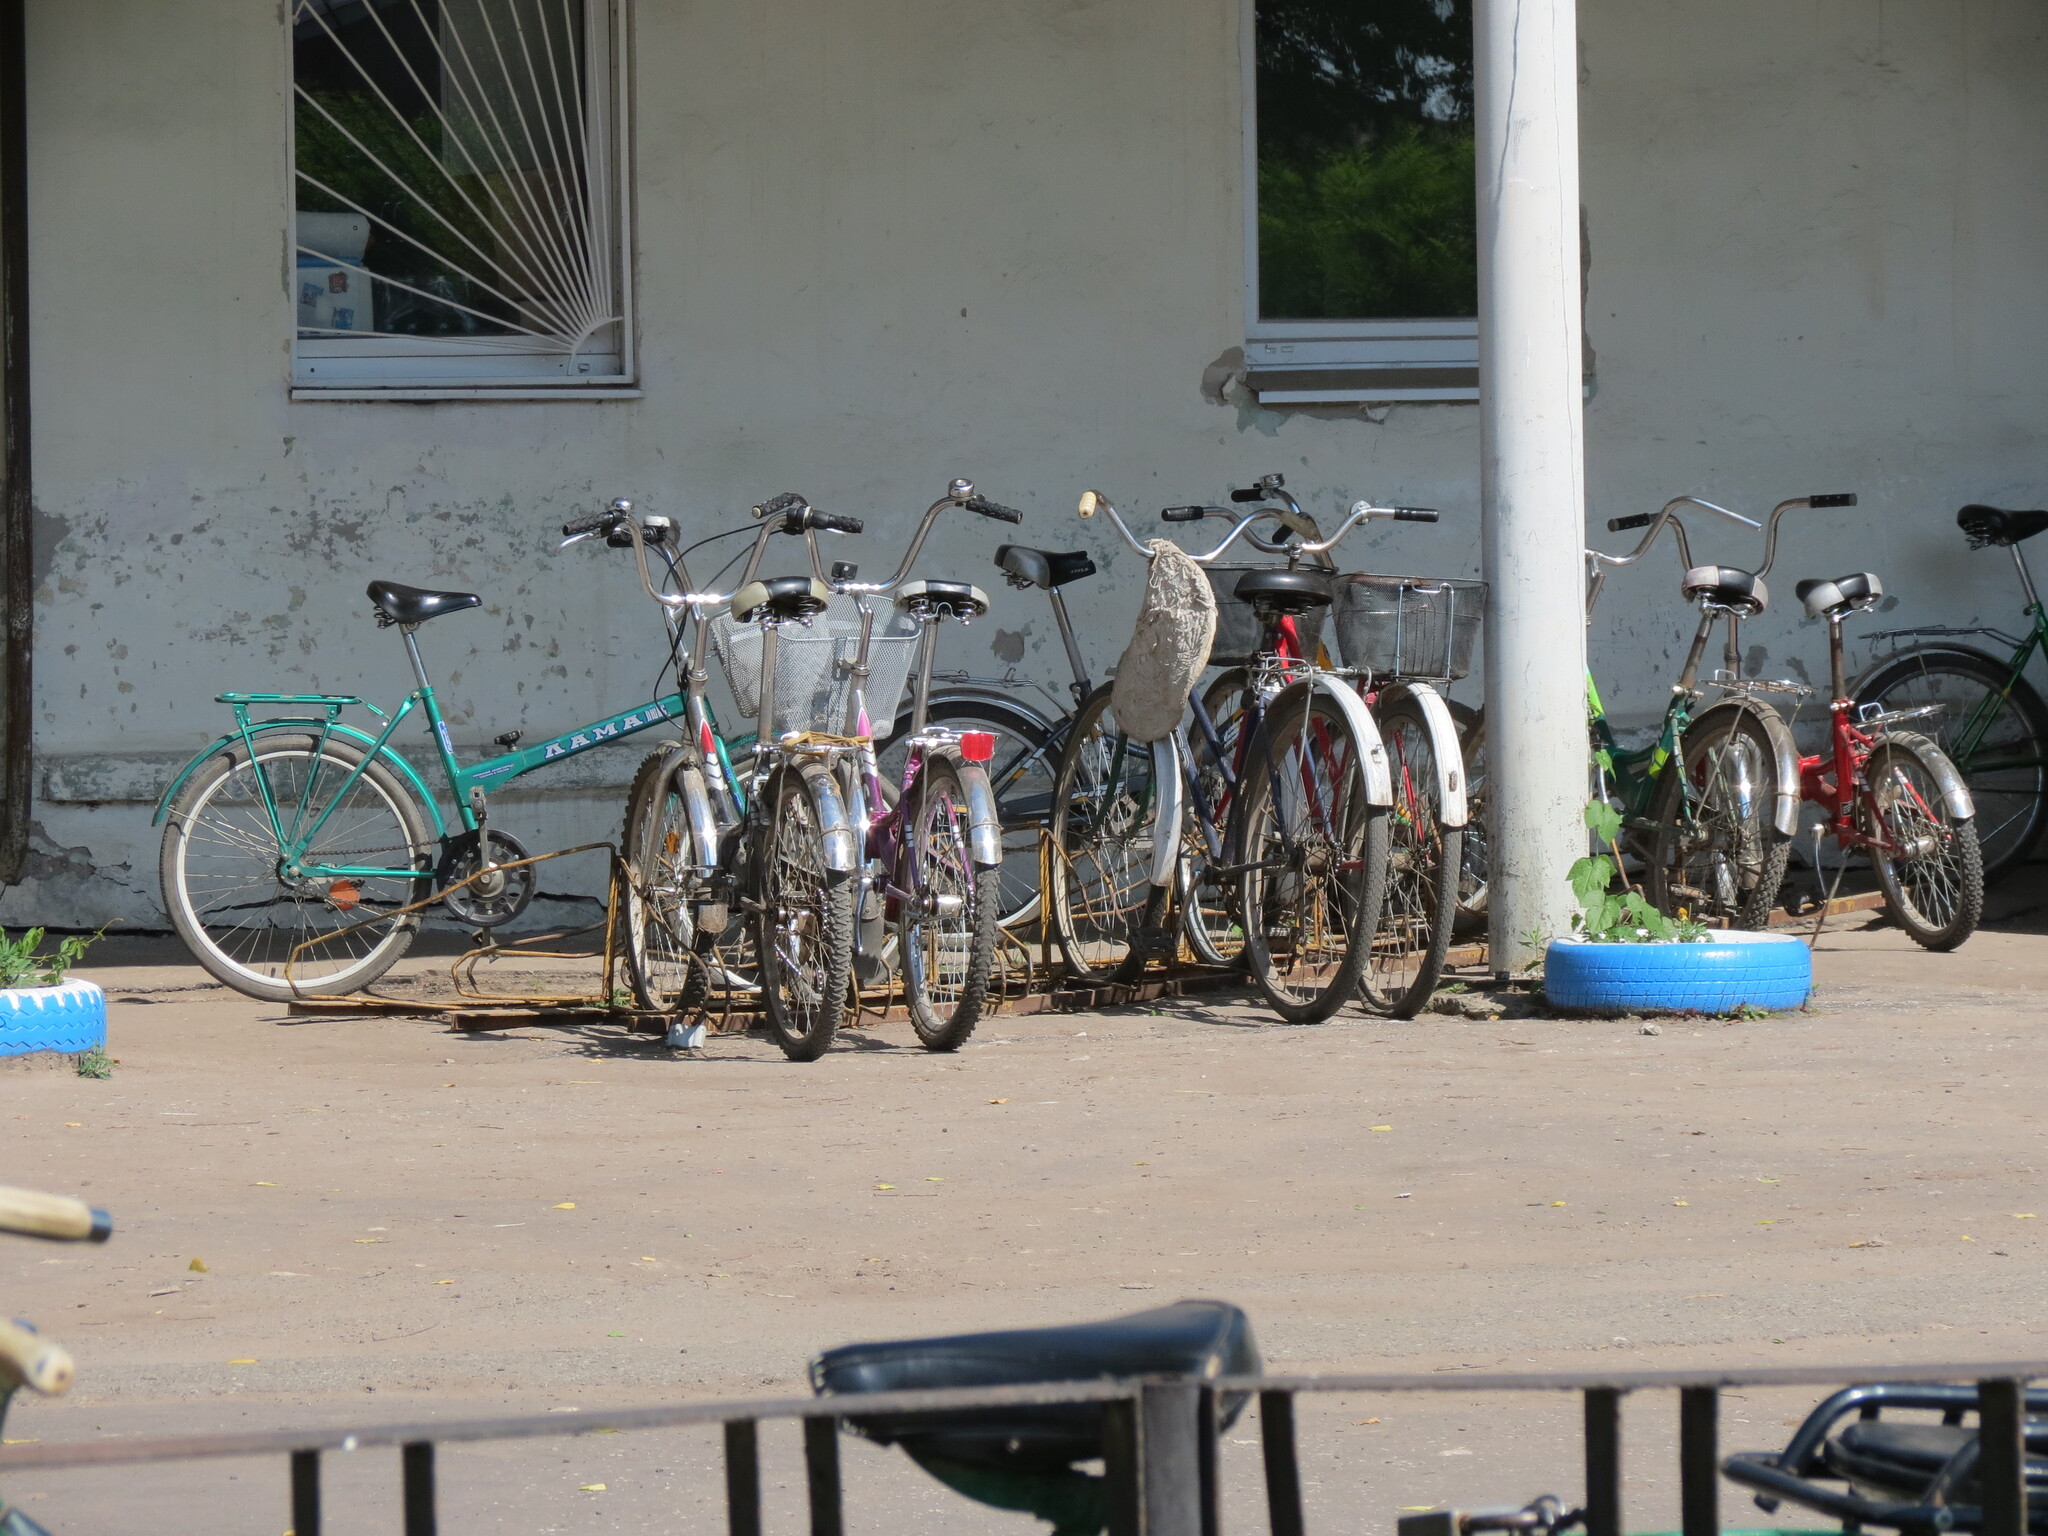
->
xmin=281 ymin=0 xmax=641 ymax=401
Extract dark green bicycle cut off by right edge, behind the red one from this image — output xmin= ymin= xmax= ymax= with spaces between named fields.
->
xmin=1849 ymin=504 xmax=2048 ymax=885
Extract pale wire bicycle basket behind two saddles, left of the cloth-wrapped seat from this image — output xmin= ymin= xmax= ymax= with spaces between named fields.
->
xmin=711 ymin=598 xmax=922 ymax=735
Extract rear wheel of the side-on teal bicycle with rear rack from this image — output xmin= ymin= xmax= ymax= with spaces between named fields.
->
xmin=158 ymin=731 xmax=434 ymax=1004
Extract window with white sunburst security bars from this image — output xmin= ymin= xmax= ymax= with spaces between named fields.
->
xmin=291 ymin=0 xmax=633 ymax=397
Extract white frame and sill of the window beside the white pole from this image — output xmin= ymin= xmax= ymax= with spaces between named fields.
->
xmin=1237 ymin=0 xmax=1479 ymax=406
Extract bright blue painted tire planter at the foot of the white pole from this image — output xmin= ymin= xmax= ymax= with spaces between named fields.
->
xmin=1542 ymin=930 xmax=1812 ymax=1014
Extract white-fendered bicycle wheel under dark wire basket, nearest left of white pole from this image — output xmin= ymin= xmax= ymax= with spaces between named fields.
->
xmin=1358 ymin=698 xmax=1464 ymax=1018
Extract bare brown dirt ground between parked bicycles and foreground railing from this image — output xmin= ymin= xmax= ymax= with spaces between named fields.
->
xmin=0 ymin=901 xmax=2048 ymax=1536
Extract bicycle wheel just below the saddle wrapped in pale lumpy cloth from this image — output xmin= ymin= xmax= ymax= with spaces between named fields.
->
xmin=1047 ymin=684 xmax=1174 ymax=981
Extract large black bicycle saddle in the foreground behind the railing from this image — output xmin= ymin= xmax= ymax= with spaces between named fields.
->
xmin=811 ymin=1300 xmax=1262 ymax=1466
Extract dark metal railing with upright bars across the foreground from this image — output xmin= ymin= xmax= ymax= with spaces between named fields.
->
xmin=0 ymin=1360 xmax=2048 ymax=1536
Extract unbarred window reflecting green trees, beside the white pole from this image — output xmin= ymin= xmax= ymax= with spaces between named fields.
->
xmin=1245 ymin=0 xmax=1479 ymax=403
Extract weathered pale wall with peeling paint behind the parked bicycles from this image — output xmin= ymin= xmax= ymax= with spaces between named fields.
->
xmin=0 ymin=0 xmax=2048 ymax=924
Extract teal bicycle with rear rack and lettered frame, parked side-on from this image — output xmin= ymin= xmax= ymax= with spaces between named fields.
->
xmin=152 ymin=502 xmax=684 ymax=1001
